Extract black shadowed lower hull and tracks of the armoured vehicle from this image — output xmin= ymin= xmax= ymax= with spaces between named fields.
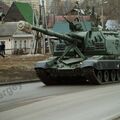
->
xmin=36 ymin=68 xmax=120 ymax=85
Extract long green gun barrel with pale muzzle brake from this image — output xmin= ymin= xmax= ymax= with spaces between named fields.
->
xmin=17 ymin=21 xmax=80 ymax=42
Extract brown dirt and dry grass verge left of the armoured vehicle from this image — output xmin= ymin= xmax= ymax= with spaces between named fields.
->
xmin=0 ymin=55 xmax=48 ymax=84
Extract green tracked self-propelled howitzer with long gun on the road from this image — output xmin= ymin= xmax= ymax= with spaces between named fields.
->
xmin=18 ymin=21 xmax=120 ymax=85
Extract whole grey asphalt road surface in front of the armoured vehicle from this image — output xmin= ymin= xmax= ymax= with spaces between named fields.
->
xmin=0 ymin=83 xmax=120 ymax=120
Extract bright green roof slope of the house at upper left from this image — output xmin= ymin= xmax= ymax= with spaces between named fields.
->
xmin=15 ymin=2 xmax=33 ymax=24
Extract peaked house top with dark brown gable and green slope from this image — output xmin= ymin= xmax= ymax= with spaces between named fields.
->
xmin=4 ymin=2 xmax=33 ymax=24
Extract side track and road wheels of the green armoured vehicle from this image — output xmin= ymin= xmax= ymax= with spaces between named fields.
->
xmin=86 ymin=68 xmax=120 ymax=85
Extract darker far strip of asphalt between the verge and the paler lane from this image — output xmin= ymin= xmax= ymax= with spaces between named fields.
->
xmin=0 ymin=82 xmax=100 ymax=112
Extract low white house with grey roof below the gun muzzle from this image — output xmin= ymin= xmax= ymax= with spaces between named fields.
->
xmin=0 ymin=22 xmax=33 ymax=54
